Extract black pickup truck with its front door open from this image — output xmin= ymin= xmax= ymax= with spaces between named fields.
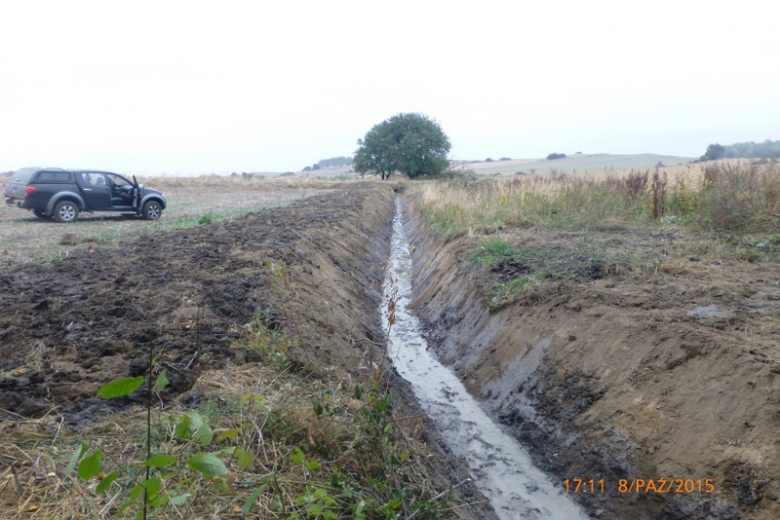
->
xmin=5 ymin=168 xmax=167 ymax=222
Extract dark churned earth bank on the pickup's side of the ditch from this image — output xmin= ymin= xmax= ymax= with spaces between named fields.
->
xmin=0 ymin=183 xmax=490 ymax=518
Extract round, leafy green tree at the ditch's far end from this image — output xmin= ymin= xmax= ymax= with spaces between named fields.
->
xmin=354 ymin=114 xmax=451 ymax=180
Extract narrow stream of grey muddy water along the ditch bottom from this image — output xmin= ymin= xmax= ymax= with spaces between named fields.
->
xmin=383 ymin=199 xmax=588 ymax=520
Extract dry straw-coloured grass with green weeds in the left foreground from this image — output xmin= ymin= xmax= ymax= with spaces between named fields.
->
xmin=0 ymin=342 xmax=449 ymax=519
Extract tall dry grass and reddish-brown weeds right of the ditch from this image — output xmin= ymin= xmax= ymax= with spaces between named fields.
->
xmin=418 ymin=161 xmax=780 ymax=234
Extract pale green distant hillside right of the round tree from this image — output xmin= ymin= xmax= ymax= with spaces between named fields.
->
xmin=465 ymin=153 xmax=695 ymax=174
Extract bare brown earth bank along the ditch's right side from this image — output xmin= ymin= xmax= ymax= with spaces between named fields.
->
xmin=407 ymin=199 xmax=780 ymax=520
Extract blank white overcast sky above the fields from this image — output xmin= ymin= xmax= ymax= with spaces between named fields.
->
xmin=0 ymin=0 xmax=780 ymax=175
